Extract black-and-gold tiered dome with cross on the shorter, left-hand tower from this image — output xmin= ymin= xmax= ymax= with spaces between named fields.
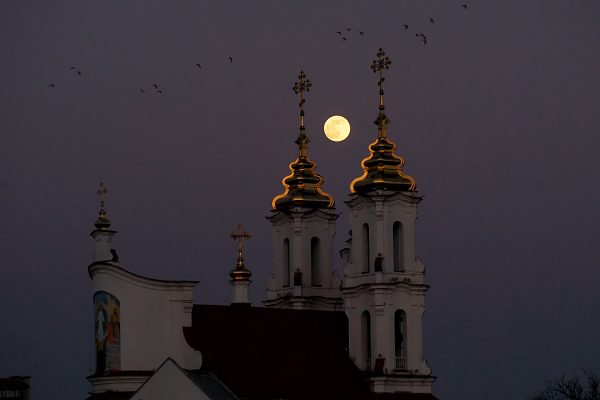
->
xmin=271 ymin=71 xmax=334 ymax=210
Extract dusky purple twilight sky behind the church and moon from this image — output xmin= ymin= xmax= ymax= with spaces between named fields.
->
xmin=0 ymin=0 xmax=600 ymax=400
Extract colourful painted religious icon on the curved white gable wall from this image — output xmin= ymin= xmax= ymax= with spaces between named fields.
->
xmin=94 ymin=292 xmax=121 ymax=374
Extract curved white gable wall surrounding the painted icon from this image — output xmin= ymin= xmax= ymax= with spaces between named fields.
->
xmin=88 ymin=225 xmax=202 ymax=393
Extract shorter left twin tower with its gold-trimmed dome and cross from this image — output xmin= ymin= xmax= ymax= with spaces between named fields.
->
xmin=264 ymin=71 xmax=342 ymax=310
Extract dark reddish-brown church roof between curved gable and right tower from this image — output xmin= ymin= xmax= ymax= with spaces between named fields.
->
xmin=184 ymin=305 xmax=436 ymax=400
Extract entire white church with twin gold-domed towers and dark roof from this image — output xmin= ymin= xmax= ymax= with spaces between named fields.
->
xmin=87 ymin=49 xmax=437 ymax=400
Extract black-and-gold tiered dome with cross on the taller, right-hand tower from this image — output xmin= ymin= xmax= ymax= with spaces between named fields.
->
xmin=350 ymin=49 xmax=416 ymax=193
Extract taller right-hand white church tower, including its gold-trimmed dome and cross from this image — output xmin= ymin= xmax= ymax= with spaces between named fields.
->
xmin=341 ymin=49 xmax=434 ymax=393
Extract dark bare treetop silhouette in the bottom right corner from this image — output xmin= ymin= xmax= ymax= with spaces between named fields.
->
xmin=529 ymin=370 xmax=600 ymax=400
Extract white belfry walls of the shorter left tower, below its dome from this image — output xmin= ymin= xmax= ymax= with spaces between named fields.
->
xmin=264 ymin=207 xmax=342 ymax=310
